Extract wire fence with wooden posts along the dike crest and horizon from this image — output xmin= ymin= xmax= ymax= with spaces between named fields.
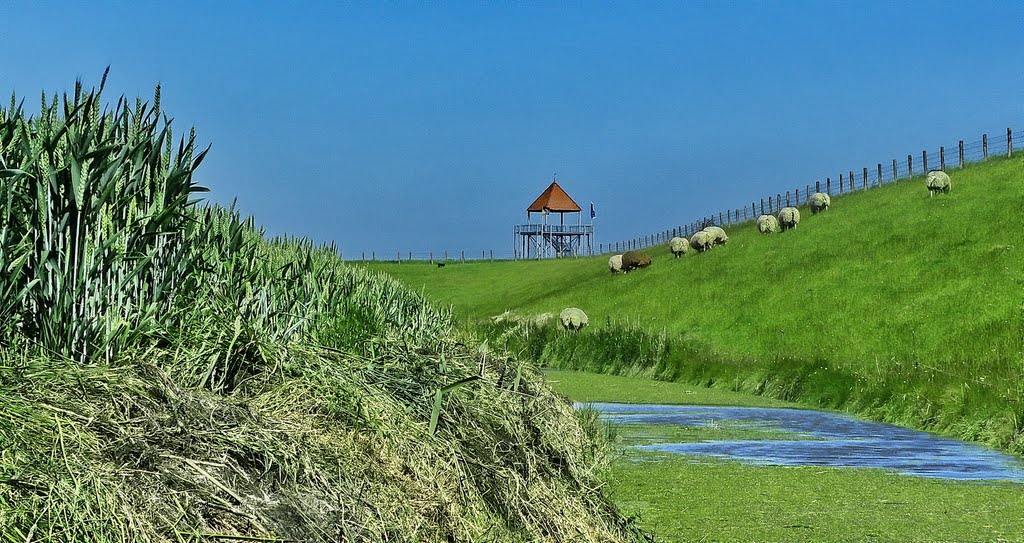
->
xmin=350 ymin=128 xmax=1024 ymax=265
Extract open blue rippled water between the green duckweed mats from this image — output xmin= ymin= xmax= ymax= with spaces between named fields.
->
xmin=588 ymin=404 xmax=1024 ymax=484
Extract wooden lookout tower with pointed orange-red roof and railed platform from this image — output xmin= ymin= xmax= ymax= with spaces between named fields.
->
xmin=513 ymin=180 xmax=594 ymax=258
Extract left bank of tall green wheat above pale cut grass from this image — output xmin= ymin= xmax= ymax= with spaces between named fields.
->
xmin=0 ymin=77 xmax=642 ymax=542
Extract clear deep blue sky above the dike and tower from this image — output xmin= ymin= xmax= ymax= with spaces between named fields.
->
xmin=0 ymin=1 xmax=1024 ymax=255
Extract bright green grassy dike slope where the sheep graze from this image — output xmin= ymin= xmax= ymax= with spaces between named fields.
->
xmin=371 ymin=157 xmax=1024 ymax=452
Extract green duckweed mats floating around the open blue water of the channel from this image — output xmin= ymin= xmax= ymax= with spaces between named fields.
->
xmin=547 ymin=371 xmax=1024 ymax=542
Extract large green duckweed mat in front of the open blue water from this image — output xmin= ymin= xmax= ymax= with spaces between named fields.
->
xmin=610 ymin=454 xmax=1024 ymax=542
